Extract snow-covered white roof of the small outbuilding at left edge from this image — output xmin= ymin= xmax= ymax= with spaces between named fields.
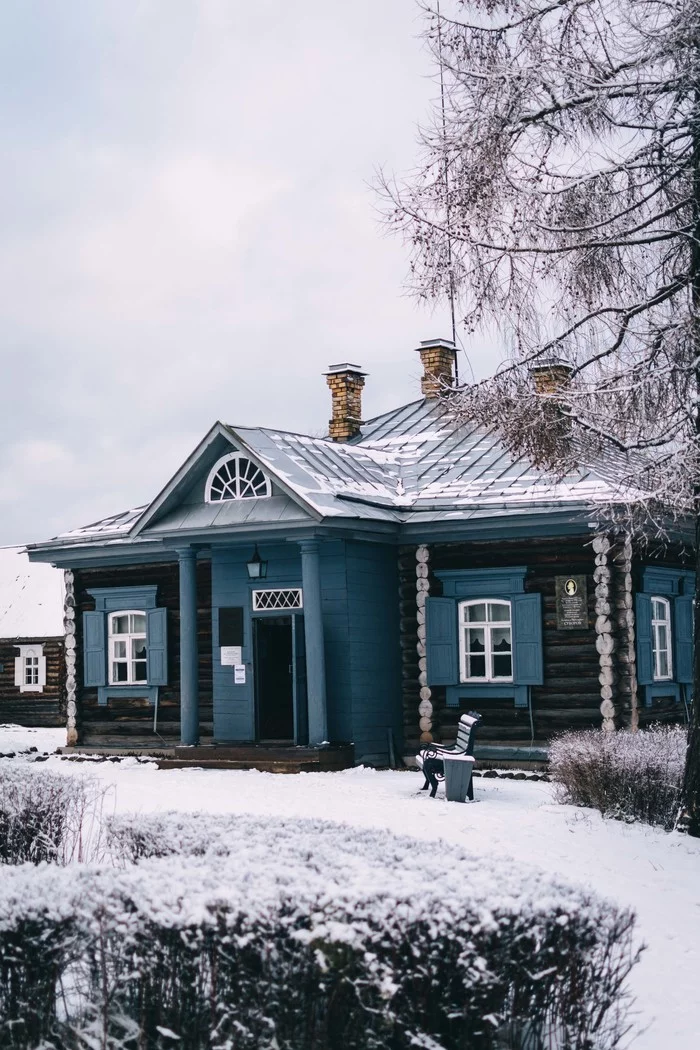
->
xmin=0 ymin=547 xmax=63 ymax=638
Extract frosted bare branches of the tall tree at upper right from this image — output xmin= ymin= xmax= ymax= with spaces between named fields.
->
xmin=381 ymin=0 xmax=700 ymax=533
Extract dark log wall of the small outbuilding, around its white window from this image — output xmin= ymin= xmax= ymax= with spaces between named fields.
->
xmin=0 ymin=637 xmax=66 ymax=728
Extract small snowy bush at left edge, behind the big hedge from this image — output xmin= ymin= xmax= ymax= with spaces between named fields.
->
xmin=0 ymin=762 xmax=104 ymax=864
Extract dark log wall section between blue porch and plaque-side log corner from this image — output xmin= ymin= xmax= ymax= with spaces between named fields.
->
xmin=399 ymin=534 xmax=601 ymax=755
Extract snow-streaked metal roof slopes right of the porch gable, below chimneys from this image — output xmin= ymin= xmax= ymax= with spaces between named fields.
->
xmin=230 ymin=399 xmax=614 ymax=521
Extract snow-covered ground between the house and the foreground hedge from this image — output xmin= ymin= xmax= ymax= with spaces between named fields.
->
xmin=0 ymin=727 xmax=700 ymax=1050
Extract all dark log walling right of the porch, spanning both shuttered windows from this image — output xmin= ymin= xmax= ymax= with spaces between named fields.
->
xmin=399 ymin=533 xmax=686 ymax=755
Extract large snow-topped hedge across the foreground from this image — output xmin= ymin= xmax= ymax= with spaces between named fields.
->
xmin=0 ymin=814 xmax=635 ymax=1050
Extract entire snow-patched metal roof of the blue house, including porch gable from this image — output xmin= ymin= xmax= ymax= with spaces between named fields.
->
xmin=30 ymin=399 xmax=616 ymax=545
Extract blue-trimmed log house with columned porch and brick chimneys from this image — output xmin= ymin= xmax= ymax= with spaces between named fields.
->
xmin=29 ymin=339 xmax=694 ymax=768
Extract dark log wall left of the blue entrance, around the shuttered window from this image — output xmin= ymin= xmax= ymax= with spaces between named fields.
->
xmin=75 ymin=561 xmax=213 ymax=748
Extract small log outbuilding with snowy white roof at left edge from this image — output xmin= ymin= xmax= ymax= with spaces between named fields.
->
xmin=0 ymin=547 xmax=66 ymax=726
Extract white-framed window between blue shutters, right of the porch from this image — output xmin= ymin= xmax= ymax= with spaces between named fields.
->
xmin=460 ymin=600 xmax=513 ymax=681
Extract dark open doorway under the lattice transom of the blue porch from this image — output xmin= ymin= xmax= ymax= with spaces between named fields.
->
xmin=253 ymin=616 xmax=294 ymax=742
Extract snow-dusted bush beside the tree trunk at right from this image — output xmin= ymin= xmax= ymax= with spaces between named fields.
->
xmin=549 ymin=726 xmax=687 ymax=830
